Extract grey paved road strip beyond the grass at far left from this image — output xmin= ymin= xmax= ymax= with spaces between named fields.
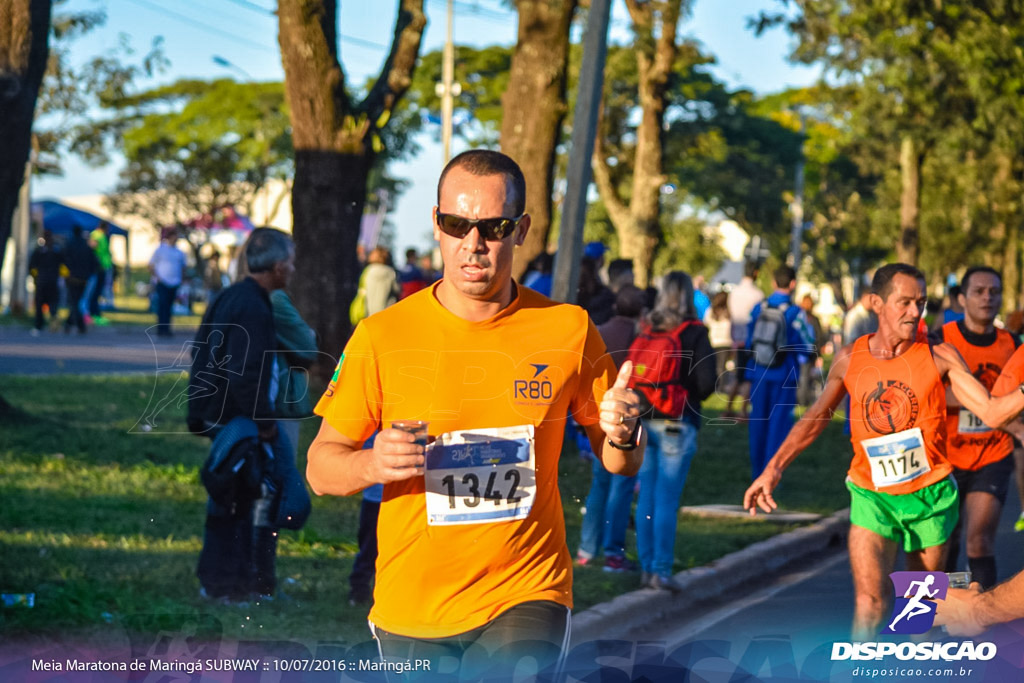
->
xmin=0 ymin=325 xmax=195 ymax=375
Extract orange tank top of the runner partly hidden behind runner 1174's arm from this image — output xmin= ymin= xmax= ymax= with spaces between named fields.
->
xmin=942 ymin=323 xmax=1017 ymax=470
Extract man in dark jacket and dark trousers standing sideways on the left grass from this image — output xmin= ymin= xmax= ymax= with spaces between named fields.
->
xmin=188 ymin=228 xmax=295 ymax=601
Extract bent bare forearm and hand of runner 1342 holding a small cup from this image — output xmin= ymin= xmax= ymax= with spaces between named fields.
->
xmin=306 ymin=419 xmax=424 ymax=496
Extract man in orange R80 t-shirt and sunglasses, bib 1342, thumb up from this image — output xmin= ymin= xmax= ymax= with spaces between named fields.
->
xmin=307 ymin=151 xmax=645 ymax=680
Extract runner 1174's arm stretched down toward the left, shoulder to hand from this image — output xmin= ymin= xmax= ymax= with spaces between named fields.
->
xmin=743 ymin=346 xmax=852 ymax=516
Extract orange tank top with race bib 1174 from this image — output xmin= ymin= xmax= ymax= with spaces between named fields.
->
xmin=843 ymin=335 xmax=952 ymax=495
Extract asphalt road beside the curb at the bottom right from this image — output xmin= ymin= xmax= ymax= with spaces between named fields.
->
xmin=602 ymin=483 xmax=1024 ymax=683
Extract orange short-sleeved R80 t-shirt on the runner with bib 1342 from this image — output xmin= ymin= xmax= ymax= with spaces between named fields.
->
xmin=315 ymin=285 xmax=616 ymax=638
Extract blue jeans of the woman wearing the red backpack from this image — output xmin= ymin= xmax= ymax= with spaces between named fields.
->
xmin=637 ymin=420 xmax=697 ymax=577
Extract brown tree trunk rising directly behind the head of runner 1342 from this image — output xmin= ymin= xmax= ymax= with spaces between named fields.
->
xmin=501 ymin=0 xmax=578 ymax=279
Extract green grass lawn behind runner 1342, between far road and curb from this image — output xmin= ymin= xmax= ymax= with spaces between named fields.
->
xmin=0 ymin=376 xmax=849 ymax=643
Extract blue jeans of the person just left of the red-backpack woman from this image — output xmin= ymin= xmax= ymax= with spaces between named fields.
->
xmin=580 ymin=457 xmax=637 ymax=558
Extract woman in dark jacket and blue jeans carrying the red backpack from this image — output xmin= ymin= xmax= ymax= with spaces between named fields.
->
xmin=634 ymin=270 xmax=717 ymax=593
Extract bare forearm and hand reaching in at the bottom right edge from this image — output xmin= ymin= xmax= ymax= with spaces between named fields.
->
xmin=935 ymin=571 xmax=1024 ymax=636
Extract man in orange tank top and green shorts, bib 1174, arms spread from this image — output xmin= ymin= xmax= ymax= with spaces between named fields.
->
xmin=743 ymin=263 xmax=1024 ymax=640
